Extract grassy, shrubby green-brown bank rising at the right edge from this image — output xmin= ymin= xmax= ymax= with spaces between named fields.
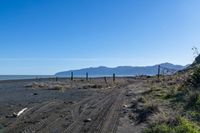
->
xmin=144 ymin=56 xmax=200 ymax=133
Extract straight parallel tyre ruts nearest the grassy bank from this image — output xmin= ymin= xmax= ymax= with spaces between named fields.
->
xmin=64 ymin=88 xmax=124 ymax=133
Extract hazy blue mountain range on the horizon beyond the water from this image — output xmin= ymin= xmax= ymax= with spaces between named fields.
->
xmin=55 ymin=63 xmax=186 ymax=76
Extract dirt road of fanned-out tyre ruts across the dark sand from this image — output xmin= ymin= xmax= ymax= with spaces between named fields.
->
xmin=0 ymin=78 xmax=148 ymax=133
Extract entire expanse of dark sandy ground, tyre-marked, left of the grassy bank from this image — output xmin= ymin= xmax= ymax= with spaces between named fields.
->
xmin=0 ymin=78 xmax=149 ymax=133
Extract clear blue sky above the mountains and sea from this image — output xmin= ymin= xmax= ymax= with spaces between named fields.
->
xmin=0 ymin=0 xmax=200 ymax=74
